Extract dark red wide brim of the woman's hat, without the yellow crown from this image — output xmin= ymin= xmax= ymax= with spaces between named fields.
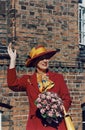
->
xmin=25 ymin=49 xmax=60 ymax=67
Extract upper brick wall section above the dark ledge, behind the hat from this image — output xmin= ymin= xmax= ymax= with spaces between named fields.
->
xmin=7 ymin=0 xmax=78 ymax=62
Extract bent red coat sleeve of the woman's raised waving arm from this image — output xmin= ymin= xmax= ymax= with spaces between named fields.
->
xmin=7 ymin=68 xmax=26 ymax=91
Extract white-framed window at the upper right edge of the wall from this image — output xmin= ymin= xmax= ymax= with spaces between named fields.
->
xmin=79 ymin=0 xmax=85 ymax=45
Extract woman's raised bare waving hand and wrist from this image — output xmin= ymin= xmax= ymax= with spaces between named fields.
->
xmin=7 ymin=43 xmax=16 ymax=69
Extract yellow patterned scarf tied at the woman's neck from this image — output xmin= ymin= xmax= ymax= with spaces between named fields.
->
xmin=37 ymin=74 xmax=54 ymax=92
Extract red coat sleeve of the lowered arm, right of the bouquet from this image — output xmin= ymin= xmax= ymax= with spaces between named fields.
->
xmin=58 ymin=74 xmax=72 ymax=111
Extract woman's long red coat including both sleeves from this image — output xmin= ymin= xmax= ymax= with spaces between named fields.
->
xmin=7 ymin=68 xmax=71 ymax=130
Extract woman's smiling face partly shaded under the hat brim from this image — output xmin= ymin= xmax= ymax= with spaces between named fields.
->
xmin=37 ymin=59 xmax=49 ymax=71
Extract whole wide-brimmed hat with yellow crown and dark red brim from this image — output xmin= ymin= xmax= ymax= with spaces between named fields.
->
xmin=25 ymin=45 xmax=60 ymax=67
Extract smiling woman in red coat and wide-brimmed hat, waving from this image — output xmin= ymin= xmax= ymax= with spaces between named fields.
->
xmin=7 ymin=44 xmax=71 ymax=130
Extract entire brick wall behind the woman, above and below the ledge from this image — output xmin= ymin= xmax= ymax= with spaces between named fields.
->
xmin=0 ymin=0 xmax=85 ymax=130
